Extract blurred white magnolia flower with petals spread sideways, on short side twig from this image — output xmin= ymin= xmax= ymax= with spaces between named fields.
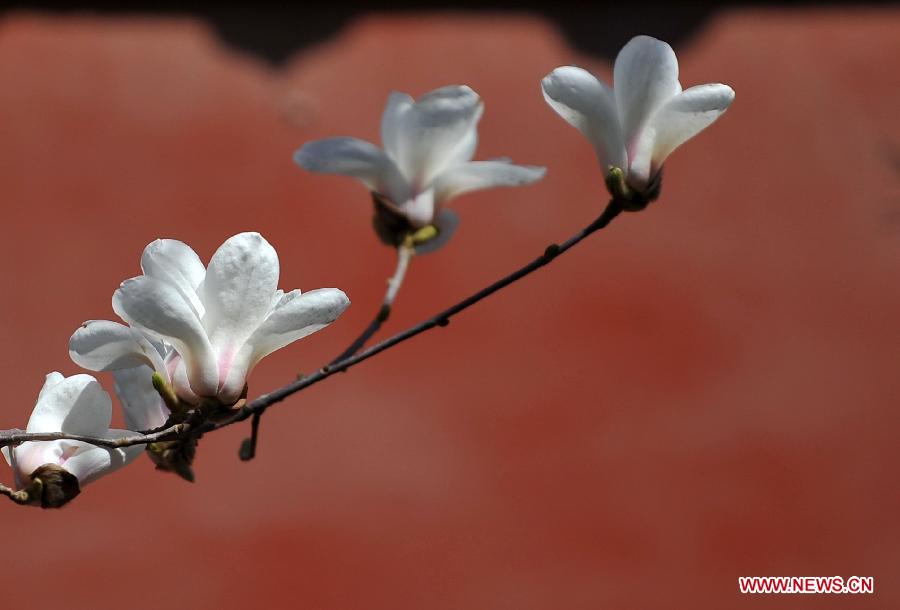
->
xmin=294 ymin=85 xmax=546 ymax=248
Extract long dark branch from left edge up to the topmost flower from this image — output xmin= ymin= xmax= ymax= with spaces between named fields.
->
xmin=0 ymin=199 xmax=623 ymax=456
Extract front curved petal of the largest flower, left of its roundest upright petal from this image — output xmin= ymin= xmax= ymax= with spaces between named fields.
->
xmin=113 ymin=276 xmax=219 ymax=396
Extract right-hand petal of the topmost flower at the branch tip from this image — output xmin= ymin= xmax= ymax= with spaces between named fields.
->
xmin=629 ymin=84 xmax=734 ymax=186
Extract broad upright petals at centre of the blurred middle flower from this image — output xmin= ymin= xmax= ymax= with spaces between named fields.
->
xmin=389 ymin=85 xmax=484 ymax=186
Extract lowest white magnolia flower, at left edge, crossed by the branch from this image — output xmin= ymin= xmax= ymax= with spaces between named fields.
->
xmin=3 ymin=372 xmax=143 ymax=505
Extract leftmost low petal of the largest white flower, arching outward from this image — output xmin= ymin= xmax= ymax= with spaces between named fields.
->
xmin=69 ymin=320 xmax=166 ymax=375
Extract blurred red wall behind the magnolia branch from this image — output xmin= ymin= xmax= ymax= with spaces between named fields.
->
xmin=0 ymin=9 xmax=900 ymax=610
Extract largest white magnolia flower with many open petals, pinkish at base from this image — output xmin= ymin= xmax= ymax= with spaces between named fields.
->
xmin=69 ymin=233 xmax=350 ymax=406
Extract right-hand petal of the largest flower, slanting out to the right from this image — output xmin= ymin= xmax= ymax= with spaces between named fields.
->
xmin=220 ymin=288 xmax=350 ymax=402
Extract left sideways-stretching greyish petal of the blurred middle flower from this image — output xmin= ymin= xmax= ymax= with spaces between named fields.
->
xmin=294 ymin=138 xmax=409 ymax=201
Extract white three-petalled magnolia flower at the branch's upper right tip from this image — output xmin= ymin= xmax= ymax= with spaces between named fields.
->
xmin=542 ymin=36 xmax=734 ymax=193
